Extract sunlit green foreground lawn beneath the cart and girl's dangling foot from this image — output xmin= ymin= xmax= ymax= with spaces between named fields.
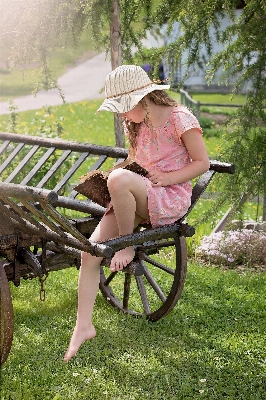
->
xmin=1 ymin=263 xmax=266 ymax=400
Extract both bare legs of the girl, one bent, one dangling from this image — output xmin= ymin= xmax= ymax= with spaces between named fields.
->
xmin=64 ymin=169 xmax=149 ymax=361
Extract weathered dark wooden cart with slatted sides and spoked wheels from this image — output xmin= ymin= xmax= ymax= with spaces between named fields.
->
xmin=0 ymin=133 xmax=234 ymax=364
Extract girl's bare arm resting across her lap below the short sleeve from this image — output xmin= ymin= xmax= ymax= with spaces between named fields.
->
xmin=147 ymin=128 xmax=210 ymax=186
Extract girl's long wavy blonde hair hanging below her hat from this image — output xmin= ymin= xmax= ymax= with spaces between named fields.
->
xmin=124 ymin=90 xmax=178 ymax=157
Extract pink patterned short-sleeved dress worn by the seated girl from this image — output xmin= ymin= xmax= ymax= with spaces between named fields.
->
xmin=136 ymin=105 xmax=202 ymax=228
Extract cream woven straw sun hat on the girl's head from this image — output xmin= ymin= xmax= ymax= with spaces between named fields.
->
xmin=98 ymin=65 xmax=170 ymax=113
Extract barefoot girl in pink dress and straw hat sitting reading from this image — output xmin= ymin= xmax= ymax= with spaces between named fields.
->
xmin=64 ymin=65 xmax=209 ymax=361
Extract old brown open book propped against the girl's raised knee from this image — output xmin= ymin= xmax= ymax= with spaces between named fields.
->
xmin=74 ymin=158 xmax=148 ymax=207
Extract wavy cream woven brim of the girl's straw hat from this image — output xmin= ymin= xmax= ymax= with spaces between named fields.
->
xmin=97 ymin=84 xmax=170 ymax=114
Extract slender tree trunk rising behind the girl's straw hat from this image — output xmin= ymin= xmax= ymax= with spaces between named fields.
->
xmin=110 ymin=0 xmax=125 ymax=147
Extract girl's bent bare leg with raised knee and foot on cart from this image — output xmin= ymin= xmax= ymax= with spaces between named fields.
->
xmin=107 ymin=168 xmax=149 ymax=271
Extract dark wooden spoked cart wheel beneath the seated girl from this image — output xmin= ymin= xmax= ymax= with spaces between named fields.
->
xmin=100 ymin=237 xmax=187 ymax=321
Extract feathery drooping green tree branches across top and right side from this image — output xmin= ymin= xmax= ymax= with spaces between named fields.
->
xmin=0 ymin=0 xmax=266 ymax=219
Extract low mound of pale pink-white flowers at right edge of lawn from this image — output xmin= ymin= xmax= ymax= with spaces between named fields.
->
xmin=197 ymin=229 xmax=266 ymax=267
